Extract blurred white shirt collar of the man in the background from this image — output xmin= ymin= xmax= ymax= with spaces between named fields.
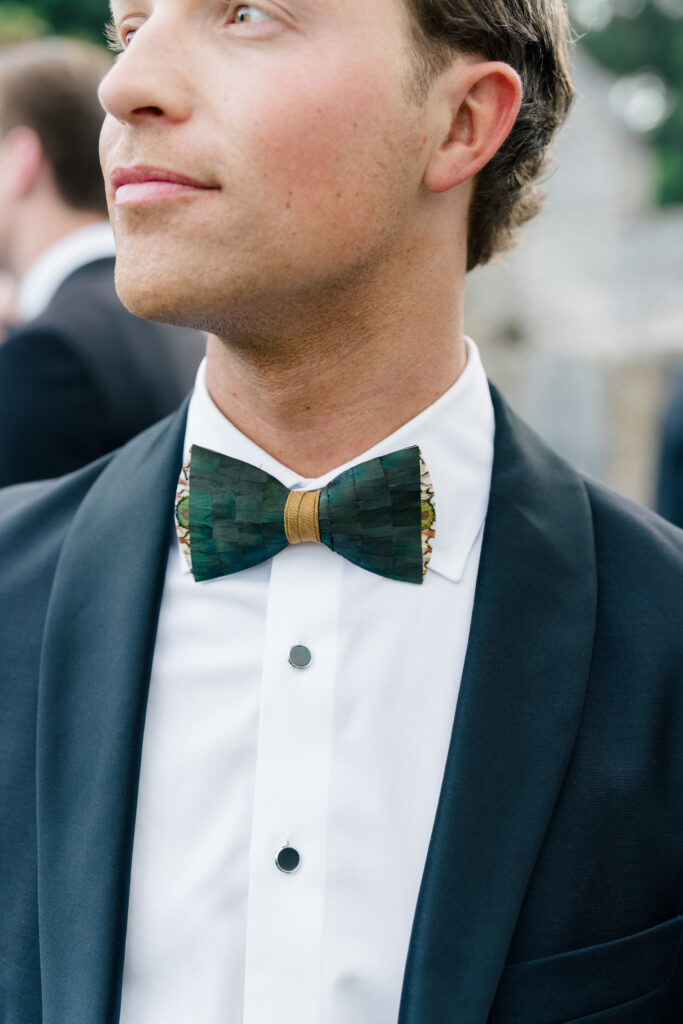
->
xmin=16 ymin=220 xmax=116 ymax=322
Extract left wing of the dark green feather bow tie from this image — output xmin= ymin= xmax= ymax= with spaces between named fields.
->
xmin=183 ymin=444 xmax=288 ymax=582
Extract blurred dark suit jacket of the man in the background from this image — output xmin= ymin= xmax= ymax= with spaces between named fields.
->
xmin=0 ymin=251 xmax=205 ymax=486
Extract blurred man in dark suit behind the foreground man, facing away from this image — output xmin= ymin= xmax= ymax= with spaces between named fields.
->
xmin=0 ymin=39 xmax=204 ymax=486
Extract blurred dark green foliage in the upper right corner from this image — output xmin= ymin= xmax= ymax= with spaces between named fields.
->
xmin=582 ymin=3 xmax=683 ymax=205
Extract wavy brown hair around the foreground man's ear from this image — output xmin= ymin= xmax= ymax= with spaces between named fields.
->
xmin=407 ymin=0 xmax=574 ymax=270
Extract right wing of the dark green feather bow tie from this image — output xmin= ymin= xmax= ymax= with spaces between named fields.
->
xmin=318 ymin=446 xmax=423 ymax=584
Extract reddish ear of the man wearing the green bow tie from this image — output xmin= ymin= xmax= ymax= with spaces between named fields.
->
xmin=423 ymin=61 xmax=522 ymax=193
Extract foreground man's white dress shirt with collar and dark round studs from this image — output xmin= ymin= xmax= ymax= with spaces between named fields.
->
xmin=121 ymin=342 xmax=495 ymax=1024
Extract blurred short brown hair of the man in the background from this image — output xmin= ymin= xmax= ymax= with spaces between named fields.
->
xmin=0 ymin=37 xmax=112 ymax=213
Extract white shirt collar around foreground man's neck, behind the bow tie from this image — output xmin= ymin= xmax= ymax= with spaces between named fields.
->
xmin=178 ymin=338 xmax=495 ymax=583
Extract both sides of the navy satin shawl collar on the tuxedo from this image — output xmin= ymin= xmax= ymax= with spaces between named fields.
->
xmin=37 ymin=389 xmax=596 ymax=1024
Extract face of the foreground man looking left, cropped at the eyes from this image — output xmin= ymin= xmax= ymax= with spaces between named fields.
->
xmin=100 ymin=0 xmax=436 ymax=331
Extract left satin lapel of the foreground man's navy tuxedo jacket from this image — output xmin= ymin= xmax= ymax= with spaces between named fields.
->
xmin=37 ymin=407 xmax=186 ymax=1024
